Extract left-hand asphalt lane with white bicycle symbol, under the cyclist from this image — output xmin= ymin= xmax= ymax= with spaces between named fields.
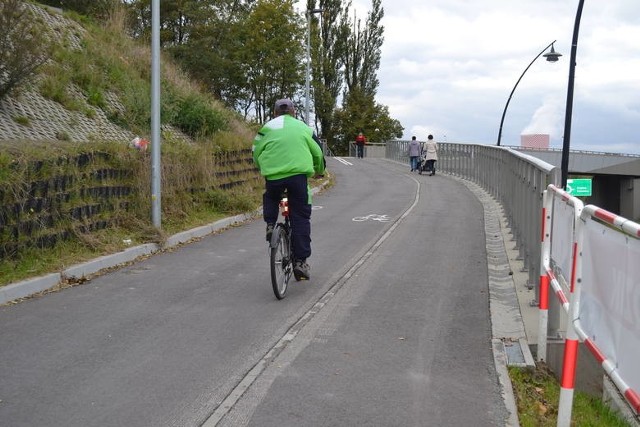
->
xmin=0 ymin=159 xmax=415 ymax=427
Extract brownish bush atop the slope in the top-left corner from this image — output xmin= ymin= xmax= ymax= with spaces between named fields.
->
xmin=0 ymin=0 xmax=51 ymax=98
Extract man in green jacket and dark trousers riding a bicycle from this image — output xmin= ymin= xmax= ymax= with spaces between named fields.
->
xmin=253 ymin=98 xmax=325 ymax=280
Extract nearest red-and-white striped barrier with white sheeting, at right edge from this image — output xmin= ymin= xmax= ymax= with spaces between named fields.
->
xmin=558 ymin=205 xmax=640 ymax=425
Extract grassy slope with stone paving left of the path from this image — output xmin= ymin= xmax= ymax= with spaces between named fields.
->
xmin=0 ymin=3 xmax=260 ymax=286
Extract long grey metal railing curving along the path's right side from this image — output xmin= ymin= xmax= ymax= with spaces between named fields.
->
xmin=385 ymin=141 xmax=560 ymax=294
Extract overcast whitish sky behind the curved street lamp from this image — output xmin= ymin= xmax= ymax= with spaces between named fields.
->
xmin=340 ymin=0 xmax=640 ymax=154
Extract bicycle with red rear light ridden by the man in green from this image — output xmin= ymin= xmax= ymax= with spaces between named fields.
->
xmin=269 ymin=190 xmax=293 ymax=300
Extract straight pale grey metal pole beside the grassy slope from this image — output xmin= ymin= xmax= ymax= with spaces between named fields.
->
xmin=151 ymin=0 xmax=162 ymax=229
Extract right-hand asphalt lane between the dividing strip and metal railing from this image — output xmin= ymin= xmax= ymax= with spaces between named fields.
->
xmin=215 ymin=160 xmax=509 ymax=426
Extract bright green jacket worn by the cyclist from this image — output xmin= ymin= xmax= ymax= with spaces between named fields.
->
xmin=253 ymin=114 xmax=324 ymax=180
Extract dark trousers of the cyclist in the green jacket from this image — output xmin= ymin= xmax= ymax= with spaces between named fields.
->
xmin=262 ymin=175 xmax=311 ymax=260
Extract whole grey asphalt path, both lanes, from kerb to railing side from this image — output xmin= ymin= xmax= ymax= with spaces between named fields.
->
xmin=0 ymin=158 xmax=507 ymax=427
